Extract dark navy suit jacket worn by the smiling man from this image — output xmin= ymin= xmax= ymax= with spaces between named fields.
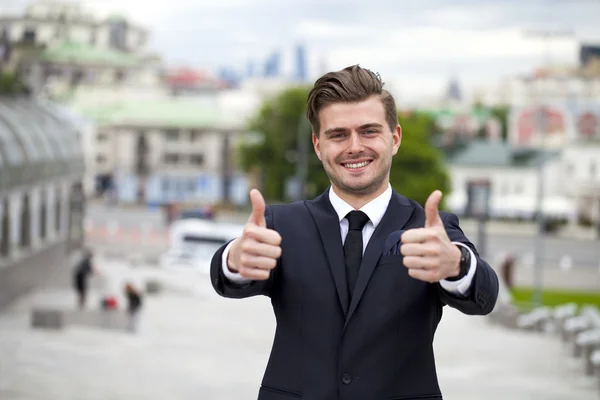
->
xmin=211 ymin=191 xmax=498 ymax=400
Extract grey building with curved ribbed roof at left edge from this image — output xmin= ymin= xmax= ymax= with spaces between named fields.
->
xmin=0 ymin=97 xmax=84 ymax=308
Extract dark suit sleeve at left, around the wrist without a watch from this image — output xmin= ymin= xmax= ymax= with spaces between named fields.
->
xmin=210 ymin=206 xmax=279 ymax=299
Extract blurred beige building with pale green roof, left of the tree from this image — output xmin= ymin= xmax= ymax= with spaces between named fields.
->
xmin=76 ymin=98 xmax=248 ymax=205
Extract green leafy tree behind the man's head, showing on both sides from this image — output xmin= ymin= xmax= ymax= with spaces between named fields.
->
xmin=240 ymin=87 xmax=450 ymax=204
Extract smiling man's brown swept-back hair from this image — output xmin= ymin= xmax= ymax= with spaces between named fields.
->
xmin=306 ymin=65 xmax=398 ymax=136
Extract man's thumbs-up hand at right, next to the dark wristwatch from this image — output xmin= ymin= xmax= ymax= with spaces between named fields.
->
xmin=400 ymin=190 xmax=461 ymax=283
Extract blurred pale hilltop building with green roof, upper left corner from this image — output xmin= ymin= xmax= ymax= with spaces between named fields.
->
xmin=0 ymin=0 xmax=161 ymax=98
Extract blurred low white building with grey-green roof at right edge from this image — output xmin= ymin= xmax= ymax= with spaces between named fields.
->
xmin=447 ymin=140 xmax=600 ymax=223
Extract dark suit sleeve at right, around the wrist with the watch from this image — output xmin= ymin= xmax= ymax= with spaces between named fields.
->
xmin=438 ymin=213 xmax=498 ymax=315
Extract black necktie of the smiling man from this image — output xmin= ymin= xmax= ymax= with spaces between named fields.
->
xmin=344 ymin=211 xmax=369 ymax=298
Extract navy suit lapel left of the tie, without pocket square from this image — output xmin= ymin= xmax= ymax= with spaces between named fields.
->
xmin=305 ymin=189 xmax=348 ymax=315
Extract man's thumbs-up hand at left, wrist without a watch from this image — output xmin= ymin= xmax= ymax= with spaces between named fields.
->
xmin=227 ymin=189 xmax=281 ymax=281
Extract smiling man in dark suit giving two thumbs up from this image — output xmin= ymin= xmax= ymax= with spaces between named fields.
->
xmin=211 ymin=66 xmax=498 ymax=400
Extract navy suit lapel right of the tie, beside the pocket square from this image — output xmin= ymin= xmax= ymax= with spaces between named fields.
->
xmin=342 ymin=191 xmax=414 ymax=329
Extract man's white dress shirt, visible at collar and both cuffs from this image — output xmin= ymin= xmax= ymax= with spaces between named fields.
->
xmin=222 ymin=185 xmax=477 ymax=295
